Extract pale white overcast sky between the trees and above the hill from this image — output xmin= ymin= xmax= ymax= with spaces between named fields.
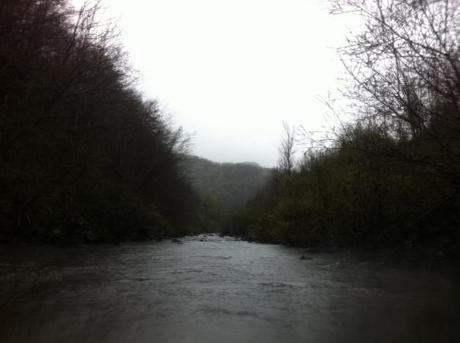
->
xmin=73 ymin=0 xmax=354 ymax=166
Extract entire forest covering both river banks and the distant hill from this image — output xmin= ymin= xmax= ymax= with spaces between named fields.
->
xmin=0 ymin=0 xmax=460 ymax=264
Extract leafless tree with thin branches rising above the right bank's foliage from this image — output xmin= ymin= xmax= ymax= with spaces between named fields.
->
xmin=333 ymin=0 xmax=460 ymax=183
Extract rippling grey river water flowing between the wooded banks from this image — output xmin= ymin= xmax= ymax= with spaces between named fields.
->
xmin=0 ymin=235 xmax=460 ymax=343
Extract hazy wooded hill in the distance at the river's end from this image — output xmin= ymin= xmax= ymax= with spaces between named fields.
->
xmin=188 ymin=156 xmax=270 ymax=232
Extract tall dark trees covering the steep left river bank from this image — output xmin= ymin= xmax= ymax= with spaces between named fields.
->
xmin=0 ymin=0 xmax=196 ymax=242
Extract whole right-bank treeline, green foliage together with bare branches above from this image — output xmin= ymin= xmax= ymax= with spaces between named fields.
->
xmin=227 ymin=0 xmax=460 ymax=256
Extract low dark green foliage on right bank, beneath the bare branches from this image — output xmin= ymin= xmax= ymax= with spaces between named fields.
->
xmin=228 ymin=126 xmax=460 ymax=252
